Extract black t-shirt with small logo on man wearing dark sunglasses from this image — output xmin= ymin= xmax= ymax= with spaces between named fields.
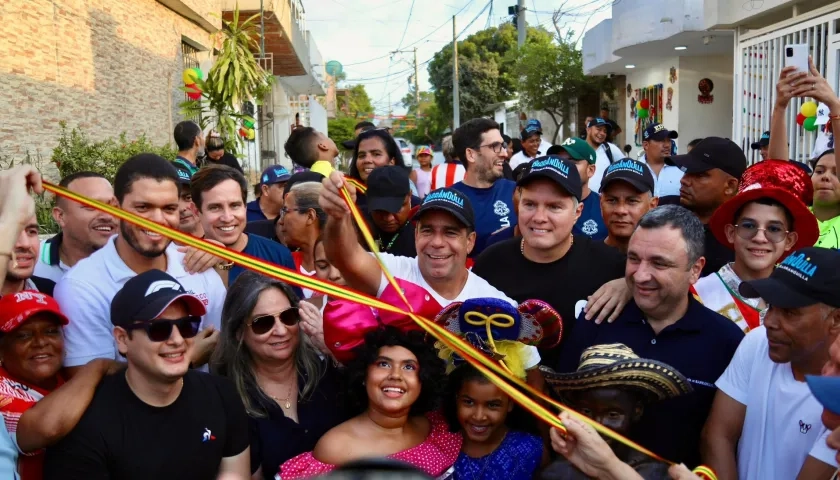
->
xmin=44 ymin=370 xmax=250 ymax=480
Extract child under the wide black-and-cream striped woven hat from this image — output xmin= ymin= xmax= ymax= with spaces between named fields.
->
xmin=535 ymin=344 xmax=692 ymax=480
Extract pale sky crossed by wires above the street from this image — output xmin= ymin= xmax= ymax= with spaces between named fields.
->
xmin=302 ymin=0 xmax=612 ymax=115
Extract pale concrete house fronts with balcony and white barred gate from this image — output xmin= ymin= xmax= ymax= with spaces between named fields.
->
xmin=583 ymin=0 xmax=840 ymax=161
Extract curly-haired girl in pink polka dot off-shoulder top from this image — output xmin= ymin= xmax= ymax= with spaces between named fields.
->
xmin=280 ymin=327 xmax=462 ymax=480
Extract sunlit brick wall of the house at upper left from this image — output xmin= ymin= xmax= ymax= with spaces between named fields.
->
xmin=0 ymin=0 xmax=221 ymax=176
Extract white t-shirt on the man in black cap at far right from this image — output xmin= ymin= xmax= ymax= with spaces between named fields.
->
xmin=716 ymin=326 xmax=837 ymax=480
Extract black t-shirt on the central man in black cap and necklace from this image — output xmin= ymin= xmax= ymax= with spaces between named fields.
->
xmin=473 ymin=235 xmax=625 ymax=365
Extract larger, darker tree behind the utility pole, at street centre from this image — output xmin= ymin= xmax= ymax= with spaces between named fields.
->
xmin=429 ymin=23 xmax=552 ymax=123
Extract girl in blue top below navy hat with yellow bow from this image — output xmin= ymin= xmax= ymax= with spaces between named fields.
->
xmin=436 ymin=298 xmax=562 ymax=480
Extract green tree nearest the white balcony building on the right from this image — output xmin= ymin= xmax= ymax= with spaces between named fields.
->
xmin=514 ymin=32 xmax=613 ymax=140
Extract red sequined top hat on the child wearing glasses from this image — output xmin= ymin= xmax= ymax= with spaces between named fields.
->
xmin=709 ymin=160 xmax=820 ymax=258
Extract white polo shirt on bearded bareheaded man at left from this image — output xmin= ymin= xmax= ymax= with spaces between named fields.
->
xmin=54 ymin=235 xmax=227 ymax=367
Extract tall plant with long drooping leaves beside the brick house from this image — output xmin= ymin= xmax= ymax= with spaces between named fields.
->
xmin=180 ymin=3 xmax=274 ymax=152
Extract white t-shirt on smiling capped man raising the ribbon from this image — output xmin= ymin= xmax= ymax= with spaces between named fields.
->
xmin=371 ymin=253 xmax=540 ymax=370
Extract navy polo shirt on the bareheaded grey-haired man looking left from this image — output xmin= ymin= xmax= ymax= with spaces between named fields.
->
xmin=557 ymin=295 xmax=744 ymax=465
